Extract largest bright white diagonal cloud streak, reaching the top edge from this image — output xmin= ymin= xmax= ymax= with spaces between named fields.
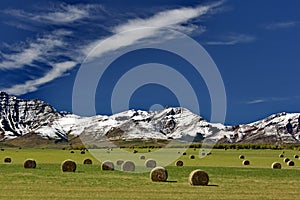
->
xmin=83 ymin=1 xmax=223 ymax=57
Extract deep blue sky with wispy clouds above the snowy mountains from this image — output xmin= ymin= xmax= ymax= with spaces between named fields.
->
xmin=0 ymin=0 xmax=300 ymax=124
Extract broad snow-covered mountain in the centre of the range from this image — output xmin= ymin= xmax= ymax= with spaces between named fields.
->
xmin=62 ymin=107 xmax=225 ymax=144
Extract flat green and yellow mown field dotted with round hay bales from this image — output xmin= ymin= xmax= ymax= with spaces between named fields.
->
xmin=0 ymin=149 xmax=300 ymax=199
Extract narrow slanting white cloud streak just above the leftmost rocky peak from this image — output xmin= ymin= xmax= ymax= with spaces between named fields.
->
xmin=2 ymin=61 xmax=77 ymax=95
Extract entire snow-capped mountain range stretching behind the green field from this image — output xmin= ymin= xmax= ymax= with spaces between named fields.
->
xmin=0 ymin=92 xmax=300 ymax=144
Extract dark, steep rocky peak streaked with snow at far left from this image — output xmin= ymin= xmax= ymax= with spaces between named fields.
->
xmin=0 ymin=92 xmax=61 ymax=138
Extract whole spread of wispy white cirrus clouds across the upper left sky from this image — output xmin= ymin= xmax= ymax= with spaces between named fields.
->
xmin=0 ymin=1 xmax=223 ymax=95
